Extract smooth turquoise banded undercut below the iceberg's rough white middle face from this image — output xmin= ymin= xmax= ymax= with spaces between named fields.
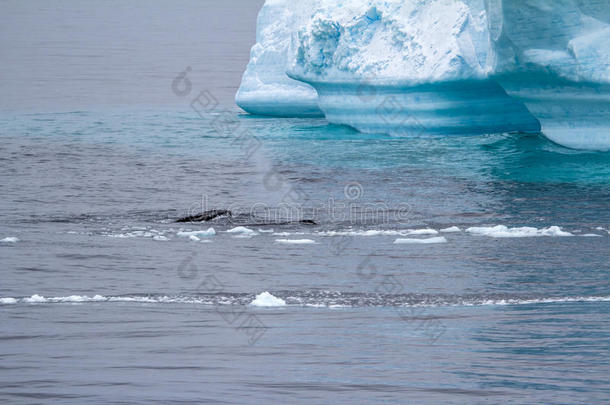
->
xmin=296 ymin=80 xmax=540 ymax=136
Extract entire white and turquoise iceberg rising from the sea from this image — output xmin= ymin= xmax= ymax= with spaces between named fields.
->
xmin=236 ymin=0 xmax=610 ymax=150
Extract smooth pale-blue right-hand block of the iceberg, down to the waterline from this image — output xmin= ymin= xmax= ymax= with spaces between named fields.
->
xmin=488 ymin=0 xmax=610 ymax=150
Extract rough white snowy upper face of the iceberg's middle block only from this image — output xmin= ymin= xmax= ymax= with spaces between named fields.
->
xmin=287 ymin=0 xmax=491 ymax=84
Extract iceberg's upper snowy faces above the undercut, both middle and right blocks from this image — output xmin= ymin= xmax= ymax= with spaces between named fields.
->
xmin=284 ymin=0 xmax=610 ymax=83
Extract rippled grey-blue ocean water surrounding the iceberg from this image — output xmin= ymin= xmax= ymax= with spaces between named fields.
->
xmin=0 ymin=1 xmax=610 ymax=404
